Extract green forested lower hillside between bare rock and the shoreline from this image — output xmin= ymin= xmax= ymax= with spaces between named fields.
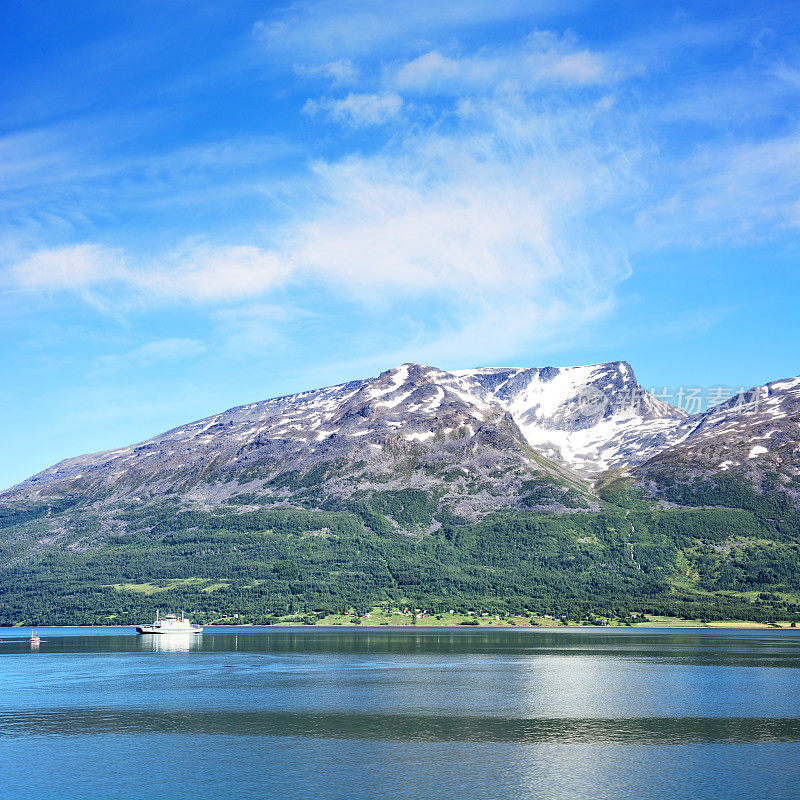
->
xmin=0 ymin=480 xmax=800 ymax=624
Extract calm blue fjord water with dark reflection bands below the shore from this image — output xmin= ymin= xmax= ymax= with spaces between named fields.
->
xmin=0 ymin=628 xmax=800 ymax=800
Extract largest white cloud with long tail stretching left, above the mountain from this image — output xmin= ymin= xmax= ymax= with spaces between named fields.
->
xmin=7 ymin=76 xmax=638 ymax=356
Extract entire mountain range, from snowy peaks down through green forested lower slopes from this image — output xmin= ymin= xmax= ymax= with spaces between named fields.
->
xmin=0 ymin=361 xmax=800 ymax=624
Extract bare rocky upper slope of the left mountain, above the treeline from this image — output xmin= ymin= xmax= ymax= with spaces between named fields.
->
xmin=0 ymin=364 xmax=600 ymax=513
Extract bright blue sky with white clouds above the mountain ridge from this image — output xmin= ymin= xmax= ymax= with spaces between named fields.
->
xmin=0 ymin=0 xmax=800 ymax=488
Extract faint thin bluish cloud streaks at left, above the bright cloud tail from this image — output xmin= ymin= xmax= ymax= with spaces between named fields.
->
xmin=0 ymin=119 xmax=298 ymax=258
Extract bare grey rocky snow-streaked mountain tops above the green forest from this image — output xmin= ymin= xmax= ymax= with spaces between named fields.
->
xmin=0 ymin=361 xmax=800 ymax=506
